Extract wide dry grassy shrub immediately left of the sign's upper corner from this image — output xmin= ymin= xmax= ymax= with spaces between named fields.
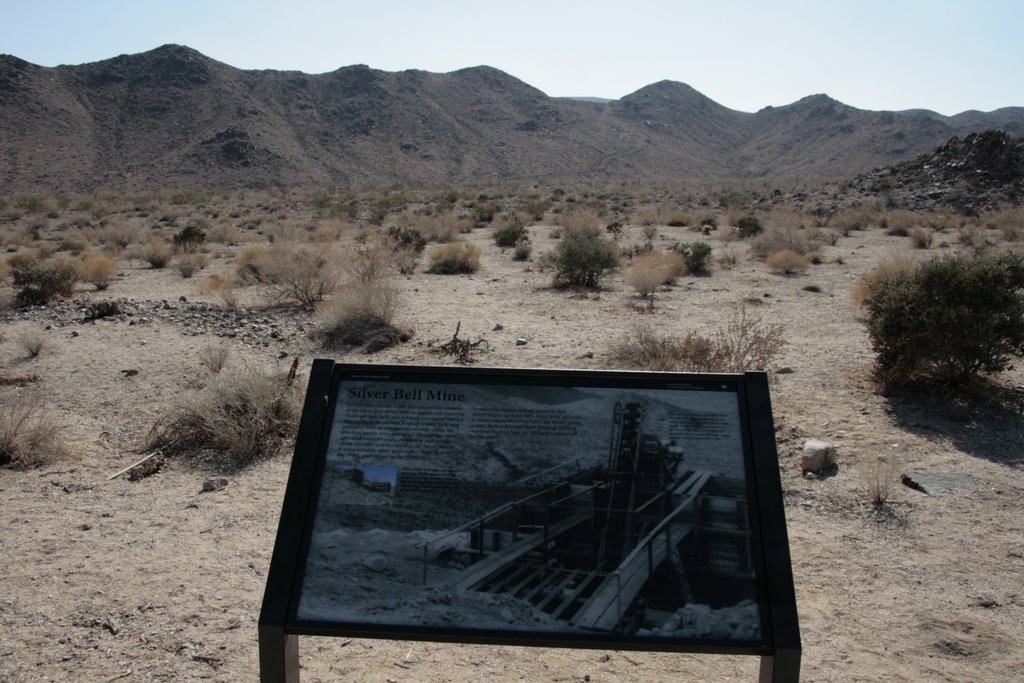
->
xmin=147 ymin=367 xmax=299 ymax=465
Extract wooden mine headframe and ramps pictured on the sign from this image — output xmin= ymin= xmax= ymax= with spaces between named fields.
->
xmin=423 ymin=401 xmax=760 ymax=639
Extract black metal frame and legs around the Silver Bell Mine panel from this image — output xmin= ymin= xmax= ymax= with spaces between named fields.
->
xmin=259 ymin=359 xmax=801 ymax=681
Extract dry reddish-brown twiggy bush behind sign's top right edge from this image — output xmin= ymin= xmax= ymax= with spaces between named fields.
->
xmin=611 ymin=307 xmax=785 ymax=373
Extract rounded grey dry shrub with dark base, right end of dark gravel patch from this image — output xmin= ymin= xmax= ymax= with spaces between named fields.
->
xmin=313 ymin=283 xmax=411 ymax=353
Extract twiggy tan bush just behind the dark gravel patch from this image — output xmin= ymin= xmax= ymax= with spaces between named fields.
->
xmin=262 ymin=243 xmax=338 ymax=307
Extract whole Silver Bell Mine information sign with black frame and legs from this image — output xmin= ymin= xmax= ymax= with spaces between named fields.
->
xmin=260 ymin=360 xmax=800 ymax=681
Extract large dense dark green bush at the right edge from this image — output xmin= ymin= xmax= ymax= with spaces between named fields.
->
xmin=863 ymin=253 xmax=1024 ymax=386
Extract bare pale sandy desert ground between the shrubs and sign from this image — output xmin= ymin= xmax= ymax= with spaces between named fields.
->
xmin=0 ymin=184 xmax=1024 ymax=683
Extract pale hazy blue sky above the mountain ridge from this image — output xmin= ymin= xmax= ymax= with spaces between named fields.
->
xmin=0 ymin=0 xmax=1024 ymax=116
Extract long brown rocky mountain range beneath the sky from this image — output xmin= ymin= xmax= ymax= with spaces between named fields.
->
xmin=0 ymin=45 xmax=1024 ymax=194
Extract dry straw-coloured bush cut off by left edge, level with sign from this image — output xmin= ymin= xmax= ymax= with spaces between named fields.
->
xmin=0 ymin=395 xmax=71 ymax=470
